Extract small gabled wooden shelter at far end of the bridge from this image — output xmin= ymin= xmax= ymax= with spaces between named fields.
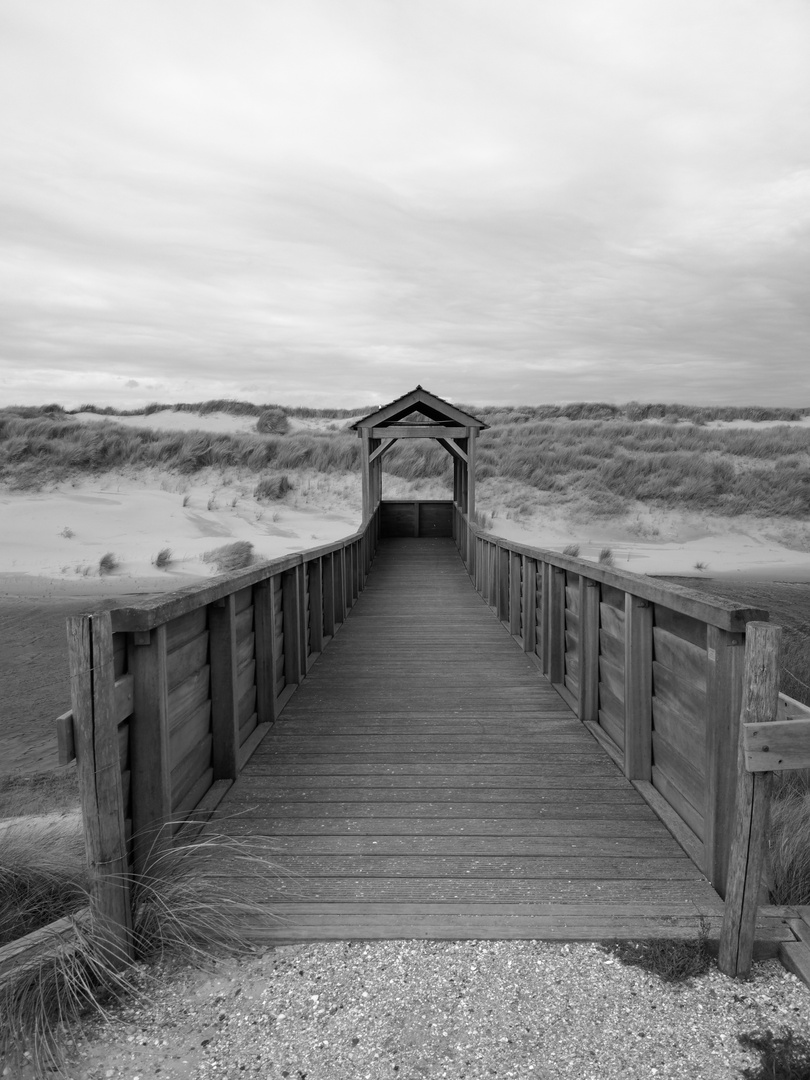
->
xmin=352 ymin=386 xmax=487 ymax=558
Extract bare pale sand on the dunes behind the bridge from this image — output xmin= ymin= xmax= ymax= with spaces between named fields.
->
xmin=0 ymin=409 xmax=810 ymax=595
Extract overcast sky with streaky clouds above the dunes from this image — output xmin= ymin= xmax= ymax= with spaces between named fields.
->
xmin=0 ymin=0 xmax=810 ymax=407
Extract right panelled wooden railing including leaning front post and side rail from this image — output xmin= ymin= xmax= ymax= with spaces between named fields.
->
xmin=454 ymin=508 xmax=810 ymax=985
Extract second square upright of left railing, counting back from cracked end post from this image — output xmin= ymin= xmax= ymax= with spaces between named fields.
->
xmin=208 ymin=593 xmax=239 ymax=780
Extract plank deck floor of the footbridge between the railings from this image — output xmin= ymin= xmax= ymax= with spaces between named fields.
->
xmin=217 ymin=539 xmax=723 ymax=941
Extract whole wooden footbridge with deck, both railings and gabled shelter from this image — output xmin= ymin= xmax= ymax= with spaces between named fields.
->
xmin=47 ymin=388 xmax=810 ymax=977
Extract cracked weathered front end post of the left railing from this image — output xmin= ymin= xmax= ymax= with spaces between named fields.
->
xmin=67 ymin=611 xmax=133 ymax=968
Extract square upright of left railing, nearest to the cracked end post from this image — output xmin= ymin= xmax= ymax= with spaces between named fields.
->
xmin=127 ymin=624 xmax=172 ymax=874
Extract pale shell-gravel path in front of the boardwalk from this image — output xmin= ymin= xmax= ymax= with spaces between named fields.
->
xmin=58 ymin=941 xmax=810 ymax=1080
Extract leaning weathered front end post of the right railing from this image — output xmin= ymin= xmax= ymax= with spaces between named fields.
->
xmin=718 ymin=622 xmax=782 ymax=978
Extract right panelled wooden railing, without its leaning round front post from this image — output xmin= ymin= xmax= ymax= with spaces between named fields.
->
xmin=455 ymin=510 xmax=768 ymax=896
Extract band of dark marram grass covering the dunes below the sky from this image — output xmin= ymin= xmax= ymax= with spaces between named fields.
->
xmin=0 ymin=402 xmax=810 ymax=517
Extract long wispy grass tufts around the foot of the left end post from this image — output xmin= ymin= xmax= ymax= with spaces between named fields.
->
xmin=0 ymin=823 xmax=285 ymax=1076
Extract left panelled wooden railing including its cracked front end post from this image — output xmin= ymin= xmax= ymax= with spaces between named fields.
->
xmin=57 ymin=512 xmax=379 ymax=959
